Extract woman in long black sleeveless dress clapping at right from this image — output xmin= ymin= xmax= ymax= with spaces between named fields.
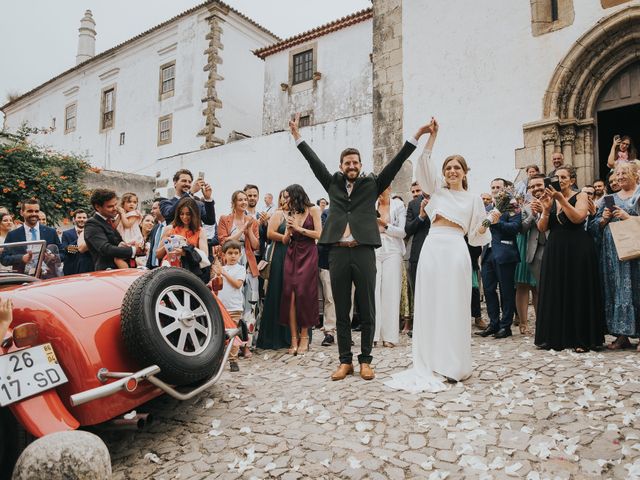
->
xmin=534 ymin=167 xmax=604 ymax=353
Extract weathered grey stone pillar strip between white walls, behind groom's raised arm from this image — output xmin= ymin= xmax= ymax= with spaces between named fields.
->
xmin=373 ymin=0 xmax=412 ymax=194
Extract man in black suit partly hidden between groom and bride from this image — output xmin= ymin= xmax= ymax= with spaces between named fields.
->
xmin=404 ymin=182 xmax=431 ymax=316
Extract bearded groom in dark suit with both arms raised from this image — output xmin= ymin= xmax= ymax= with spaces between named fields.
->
xmin=289 ymin=114 xmax=433 ymax=380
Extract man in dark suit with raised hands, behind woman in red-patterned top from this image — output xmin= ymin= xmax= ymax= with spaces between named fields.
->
xmin=160 ymin=168 xmax=216 ymax=225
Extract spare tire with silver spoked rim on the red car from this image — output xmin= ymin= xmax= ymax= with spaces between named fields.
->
xmin=120 ymin=267 xmax=225 ymax=385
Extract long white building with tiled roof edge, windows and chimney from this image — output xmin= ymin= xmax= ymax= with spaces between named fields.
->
xmin=2 ymin=1 xmax=279 ymax=173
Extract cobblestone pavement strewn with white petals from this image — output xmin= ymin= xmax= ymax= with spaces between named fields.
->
xmin=107 ymin=327 xmax=640 ymax=480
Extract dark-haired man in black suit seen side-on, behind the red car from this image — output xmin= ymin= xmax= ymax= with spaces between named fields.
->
xmin=84 ymin=188 xmax=144 ymax=271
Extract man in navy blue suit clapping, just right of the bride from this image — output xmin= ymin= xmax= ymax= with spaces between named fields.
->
xmin=476 ymin=178 xmax=522 ymax=338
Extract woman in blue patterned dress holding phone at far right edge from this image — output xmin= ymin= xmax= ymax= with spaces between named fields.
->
xmin=589 ymin=162 xmax=640 ymax=351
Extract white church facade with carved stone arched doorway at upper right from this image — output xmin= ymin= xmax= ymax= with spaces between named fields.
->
xmin=398 ymin=0 xmax=640 ymax=190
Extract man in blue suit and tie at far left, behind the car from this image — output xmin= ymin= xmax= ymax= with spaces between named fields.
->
xmin=0 ymin=198 xmax=60 ymax=274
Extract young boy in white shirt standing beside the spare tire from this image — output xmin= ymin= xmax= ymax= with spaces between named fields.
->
xmin=213 ymin=240 xmax=249 ymax=372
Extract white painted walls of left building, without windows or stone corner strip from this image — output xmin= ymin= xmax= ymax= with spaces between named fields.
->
xmin=5 ymin=9 xmax=273 ymax=173
